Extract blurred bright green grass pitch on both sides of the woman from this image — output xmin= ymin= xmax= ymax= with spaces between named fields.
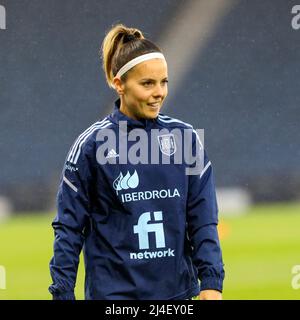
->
xmin=0 ymin=204 xmax=300 ymax=300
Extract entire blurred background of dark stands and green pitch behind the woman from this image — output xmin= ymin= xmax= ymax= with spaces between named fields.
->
xmin=0 ymin=0 xmax=300 ymax=299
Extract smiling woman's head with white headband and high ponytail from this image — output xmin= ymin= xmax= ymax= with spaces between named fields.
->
xmin=102 ymin=25 xmax=168 ymax=120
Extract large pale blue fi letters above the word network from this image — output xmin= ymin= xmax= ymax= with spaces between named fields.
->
xmin=133 ymin=211 xmax=166 ymax=249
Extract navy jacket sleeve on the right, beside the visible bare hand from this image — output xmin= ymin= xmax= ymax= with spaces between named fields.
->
xmin=187 ymin=131 xmax=225 ymax=292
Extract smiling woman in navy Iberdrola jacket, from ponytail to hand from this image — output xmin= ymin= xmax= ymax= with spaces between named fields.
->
xmin=49 ymin=24 xmax=224 ymax=300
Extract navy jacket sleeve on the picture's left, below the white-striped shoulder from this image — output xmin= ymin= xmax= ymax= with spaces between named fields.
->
xmin=49 ymin=139 xmax=92 ymax=300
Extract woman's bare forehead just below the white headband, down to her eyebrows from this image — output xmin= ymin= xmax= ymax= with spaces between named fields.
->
xmin=130 ymin=59 xmax=168 ymax=79
